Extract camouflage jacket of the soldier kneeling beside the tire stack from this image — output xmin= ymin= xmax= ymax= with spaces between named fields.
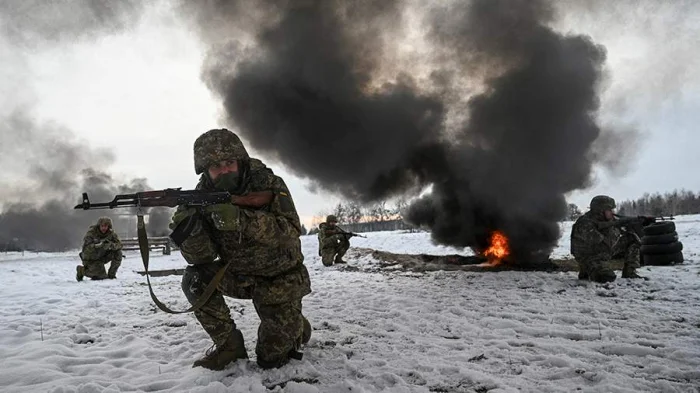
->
xmin=571 ymin=212 xmax=620 ymax=260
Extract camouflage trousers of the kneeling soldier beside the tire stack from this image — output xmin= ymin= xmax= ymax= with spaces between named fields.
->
xmin=576 ymin=235 xmax=641 ymax=282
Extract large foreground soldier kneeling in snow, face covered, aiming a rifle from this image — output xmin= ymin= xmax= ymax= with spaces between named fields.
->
xmin=171 ymin=129 xmax=311 ymax=370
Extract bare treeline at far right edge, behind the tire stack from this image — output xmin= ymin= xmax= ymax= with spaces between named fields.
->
xmin=617 ymin=190 xmax=700 ymax=216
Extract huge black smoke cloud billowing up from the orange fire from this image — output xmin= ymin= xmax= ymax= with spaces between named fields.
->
xmin=189 ymin=0 xmax=620 ymax=261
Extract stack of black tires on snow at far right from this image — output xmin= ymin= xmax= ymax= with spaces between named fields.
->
xmin=641 ymin=221 xmax=683 ymax=266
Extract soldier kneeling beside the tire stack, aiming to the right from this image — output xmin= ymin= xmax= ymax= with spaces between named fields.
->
xmin=571 ymin=195 xmax=643 ymax=283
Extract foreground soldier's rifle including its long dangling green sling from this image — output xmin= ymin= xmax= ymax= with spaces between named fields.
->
xmin=74 ymin=188 xmax=274 ymax=314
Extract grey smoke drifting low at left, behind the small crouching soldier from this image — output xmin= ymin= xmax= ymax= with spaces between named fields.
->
xmin=0 ymin=112 xmax=170 ymax=251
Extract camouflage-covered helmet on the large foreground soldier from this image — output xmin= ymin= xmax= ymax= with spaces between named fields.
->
xmin=194 ymin=128 xmax=250 ymax=175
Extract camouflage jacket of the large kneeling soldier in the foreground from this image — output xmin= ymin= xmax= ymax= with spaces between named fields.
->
xmin=170 ymin=159 xmax=304 ymax=277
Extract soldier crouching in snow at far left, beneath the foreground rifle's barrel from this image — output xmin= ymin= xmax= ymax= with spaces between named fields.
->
xmin=75 ymin=217 xmax=123 ymax=281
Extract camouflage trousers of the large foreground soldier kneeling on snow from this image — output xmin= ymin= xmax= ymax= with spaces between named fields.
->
xmin=182 ymin=263 xmax=311 ymax=365
